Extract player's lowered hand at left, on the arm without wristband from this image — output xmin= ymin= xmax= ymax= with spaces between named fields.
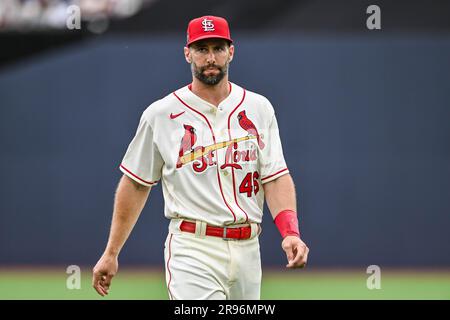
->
xmin=92 ymin=254 xmax=119 ymax=297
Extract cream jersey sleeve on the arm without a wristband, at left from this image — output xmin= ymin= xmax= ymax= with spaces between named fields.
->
xmin=120 ymin=114 xmax=164 ymax=187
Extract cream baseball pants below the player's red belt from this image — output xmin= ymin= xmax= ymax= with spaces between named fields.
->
xmin=164 ymin=219 xmax=262 ymax=300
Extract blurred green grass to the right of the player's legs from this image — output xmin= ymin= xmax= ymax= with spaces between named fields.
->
xmin=261 ymin=271 xmax=450 ymax=300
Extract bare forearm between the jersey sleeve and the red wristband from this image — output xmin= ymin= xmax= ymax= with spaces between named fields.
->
xmin=263 ymin=174 xmax=297 ymax=219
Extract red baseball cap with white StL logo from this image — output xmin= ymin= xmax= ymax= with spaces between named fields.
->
xmin=186 ymin=16 xmax=233 ymax=46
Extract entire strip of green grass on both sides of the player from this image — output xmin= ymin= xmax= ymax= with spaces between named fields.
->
xmin=0 ymin=268 xmax=450 ymax=300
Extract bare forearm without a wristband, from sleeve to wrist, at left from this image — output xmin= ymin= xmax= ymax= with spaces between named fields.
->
xmin=105 ymin=175 xmax=151 ymax=256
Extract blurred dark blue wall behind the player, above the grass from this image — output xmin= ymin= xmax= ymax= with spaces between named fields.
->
xmin=0 ymin=34 xmax=450 ymax=267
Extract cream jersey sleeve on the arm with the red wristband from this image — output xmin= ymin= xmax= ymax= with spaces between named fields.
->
xmin=260 ymin=114 xmax=289 ymax=184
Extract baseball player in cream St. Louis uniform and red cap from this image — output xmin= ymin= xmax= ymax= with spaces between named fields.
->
xmin=93 ymin=16 xmax=309 ymax=299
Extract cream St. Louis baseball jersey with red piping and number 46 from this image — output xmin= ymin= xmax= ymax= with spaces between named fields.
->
xmin=120 ymin=82 xmax=289 ymax=226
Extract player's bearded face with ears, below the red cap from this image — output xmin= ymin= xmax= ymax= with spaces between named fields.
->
xmin=185 ymin=39 xmax=234 ymax=86
